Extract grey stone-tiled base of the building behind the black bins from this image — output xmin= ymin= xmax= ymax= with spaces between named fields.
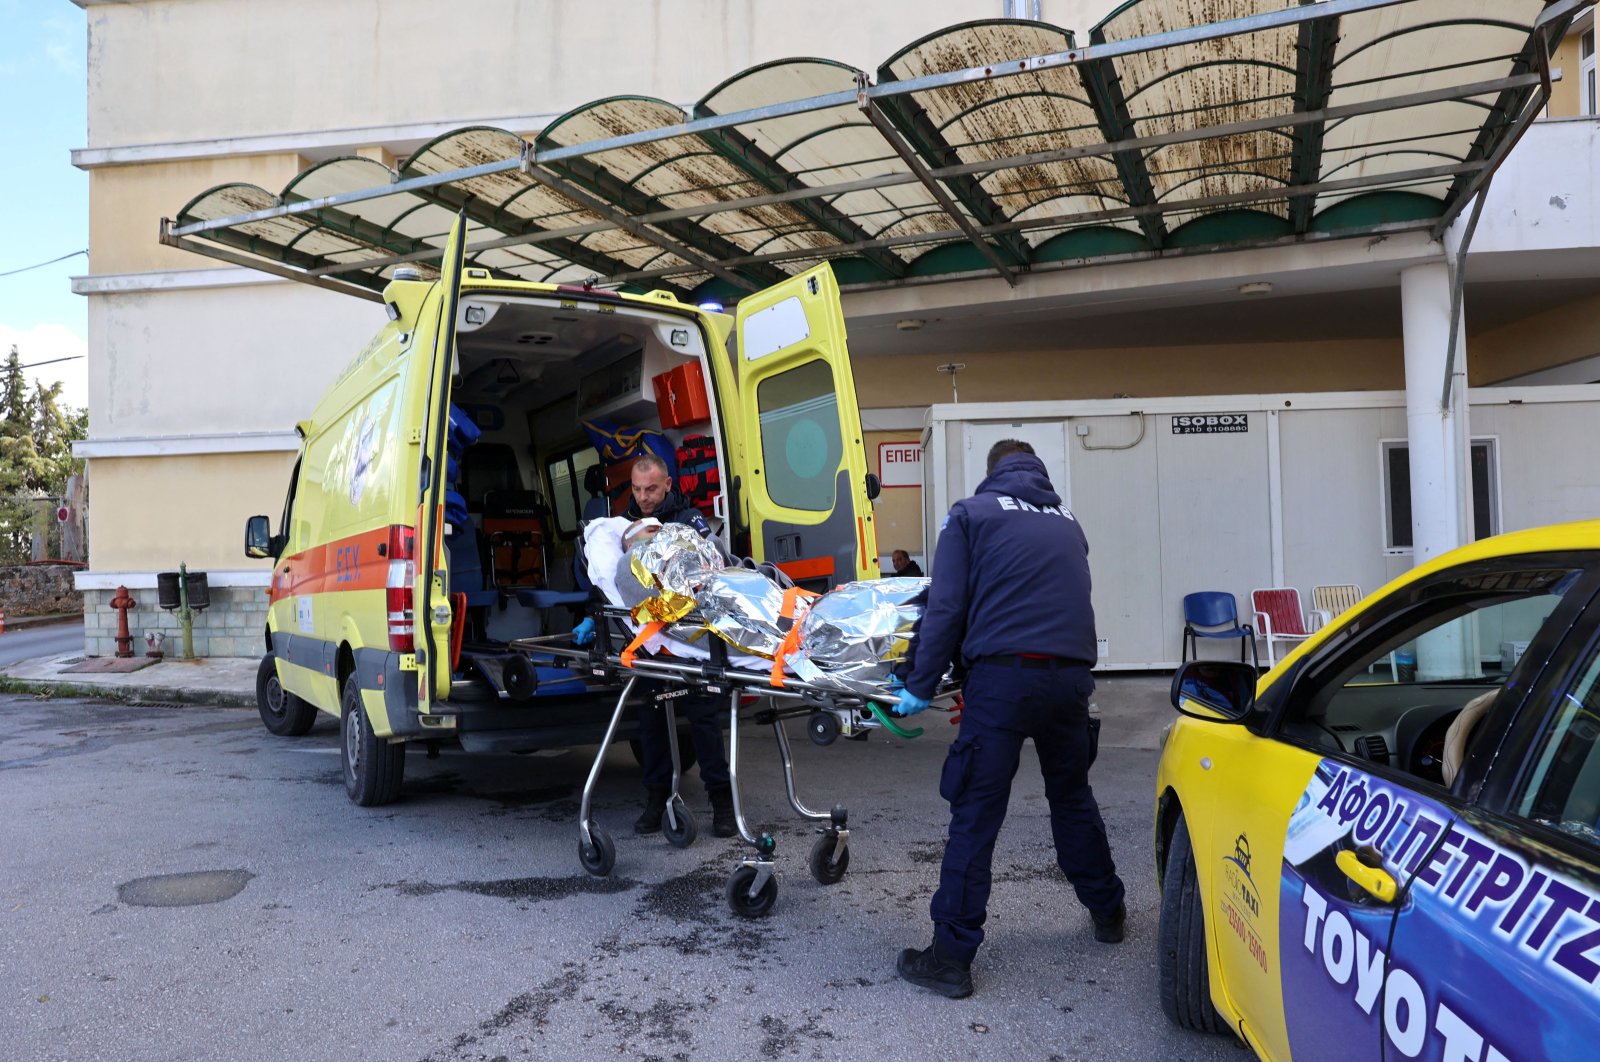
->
xmin=83 ymin=587 xmax=267 ymax=656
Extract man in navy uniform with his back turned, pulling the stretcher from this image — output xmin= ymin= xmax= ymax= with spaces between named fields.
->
xmin=896 ymin=440 xmax=1126 ymax=998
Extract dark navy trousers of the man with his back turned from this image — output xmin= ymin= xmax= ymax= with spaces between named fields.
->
xmin=930 ymin=662 xmax=1123 ymax=963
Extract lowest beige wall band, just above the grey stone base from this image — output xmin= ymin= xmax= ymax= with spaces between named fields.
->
xmin=90 ymin=453 xmax=294 ymax=571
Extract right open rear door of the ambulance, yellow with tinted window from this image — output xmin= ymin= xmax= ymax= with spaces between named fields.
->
xmin=733 ymin=262 xmax=878 ymax=590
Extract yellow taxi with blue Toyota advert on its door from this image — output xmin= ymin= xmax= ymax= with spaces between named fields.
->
xmin=1155 ymin=521 xmax=1600 ymax=1062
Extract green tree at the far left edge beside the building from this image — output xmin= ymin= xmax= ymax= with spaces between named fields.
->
xmin=0 ymin=345 xmax=88 ymax=563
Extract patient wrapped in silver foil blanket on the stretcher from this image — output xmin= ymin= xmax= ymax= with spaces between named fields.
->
xmin=584 ymin=517 xmax=928 ymax=694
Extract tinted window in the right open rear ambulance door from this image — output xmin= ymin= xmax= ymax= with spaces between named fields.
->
xmin=755 ymin=360 xmax=843 ymax=512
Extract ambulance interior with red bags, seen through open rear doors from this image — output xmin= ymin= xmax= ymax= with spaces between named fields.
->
xmin=445 ymin=289 xmax=726 ymax=646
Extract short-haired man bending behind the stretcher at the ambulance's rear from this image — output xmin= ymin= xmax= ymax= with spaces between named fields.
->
xmin=627 ymin=454 xmax=739 ymax=836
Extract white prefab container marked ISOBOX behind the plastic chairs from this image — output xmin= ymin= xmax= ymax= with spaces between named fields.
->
xmin=923 ymin=385 xmax=1600 ymax=670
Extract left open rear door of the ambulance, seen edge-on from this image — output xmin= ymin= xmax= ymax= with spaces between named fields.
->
xmin=413 ymin=211 xmax=467 ymax=712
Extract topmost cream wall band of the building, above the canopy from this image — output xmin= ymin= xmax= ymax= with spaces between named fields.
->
xmin=88 ymin=0 xmax=1062 ymax=147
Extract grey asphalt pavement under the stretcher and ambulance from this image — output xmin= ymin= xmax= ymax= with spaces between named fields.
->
xmin=0 ymin=681 xmax=1248 ymax=1062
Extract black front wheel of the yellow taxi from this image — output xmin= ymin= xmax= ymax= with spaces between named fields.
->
xmin=1155 ymin=816 xmax=1227 ymax=1033
